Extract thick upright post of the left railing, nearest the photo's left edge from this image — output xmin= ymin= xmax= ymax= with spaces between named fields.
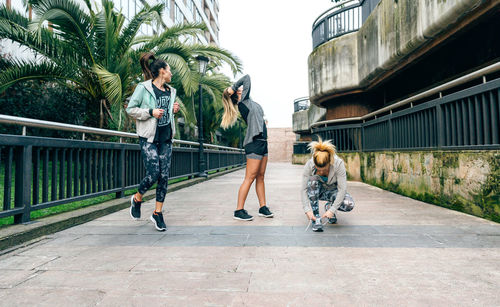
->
xmin=14 ymin=145 xmax=33 ymax=224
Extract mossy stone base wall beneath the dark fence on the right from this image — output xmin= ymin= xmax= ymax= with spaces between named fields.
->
xmin=294 ymin=150 xmax=500 ymax=222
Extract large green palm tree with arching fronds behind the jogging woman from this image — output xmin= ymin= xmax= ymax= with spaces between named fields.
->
xmin=0 ymin=0 xmax=241 ymax=134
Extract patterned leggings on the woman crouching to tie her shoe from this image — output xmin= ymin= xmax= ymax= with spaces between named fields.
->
xmin=307 ymin=175 xmax=354 ymax=217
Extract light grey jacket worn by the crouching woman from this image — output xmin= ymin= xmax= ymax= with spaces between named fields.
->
xmin=300 ymin=155 xmax=347 ymax=213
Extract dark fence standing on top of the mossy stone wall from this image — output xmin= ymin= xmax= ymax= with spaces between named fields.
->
xmin=313 ymin=79 xmax=500 ymax=152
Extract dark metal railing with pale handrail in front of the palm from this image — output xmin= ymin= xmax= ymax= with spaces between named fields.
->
xmin=0 ymin=115 xmax=245 ymax=223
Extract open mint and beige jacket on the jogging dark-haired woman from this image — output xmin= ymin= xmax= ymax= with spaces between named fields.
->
xmin=126 ymin=80 xmax=176 ymax=143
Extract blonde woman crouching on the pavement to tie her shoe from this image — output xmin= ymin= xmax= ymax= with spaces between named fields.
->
xmin=301 ymin=139 xmax=354 ymax=232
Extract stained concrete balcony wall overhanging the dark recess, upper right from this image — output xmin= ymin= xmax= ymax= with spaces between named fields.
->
xmin=309 ymin=0 xmax=490 ymax=105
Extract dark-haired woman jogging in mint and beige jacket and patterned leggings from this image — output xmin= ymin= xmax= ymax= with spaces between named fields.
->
xmin=127 ymin=53 xmax=179 ymax=231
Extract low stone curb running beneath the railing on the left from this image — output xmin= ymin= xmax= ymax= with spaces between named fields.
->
xmin=0 ymin=166 xmax=244 ymax=254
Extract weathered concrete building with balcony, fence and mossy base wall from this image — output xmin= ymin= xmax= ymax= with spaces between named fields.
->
xmin=293 ymin=0 xmax=500 ymax=221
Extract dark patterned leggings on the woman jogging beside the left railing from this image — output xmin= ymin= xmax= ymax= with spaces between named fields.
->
xmin=139 ymin=138 xmax=172 ymax=202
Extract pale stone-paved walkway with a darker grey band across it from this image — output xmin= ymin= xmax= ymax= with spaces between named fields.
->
xmin=0 ymin=163 xmax=500 ymax=306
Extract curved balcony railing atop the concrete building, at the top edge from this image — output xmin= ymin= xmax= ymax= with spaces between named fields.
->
xmin=312 ymin=0 xmax=363 ymax=49
